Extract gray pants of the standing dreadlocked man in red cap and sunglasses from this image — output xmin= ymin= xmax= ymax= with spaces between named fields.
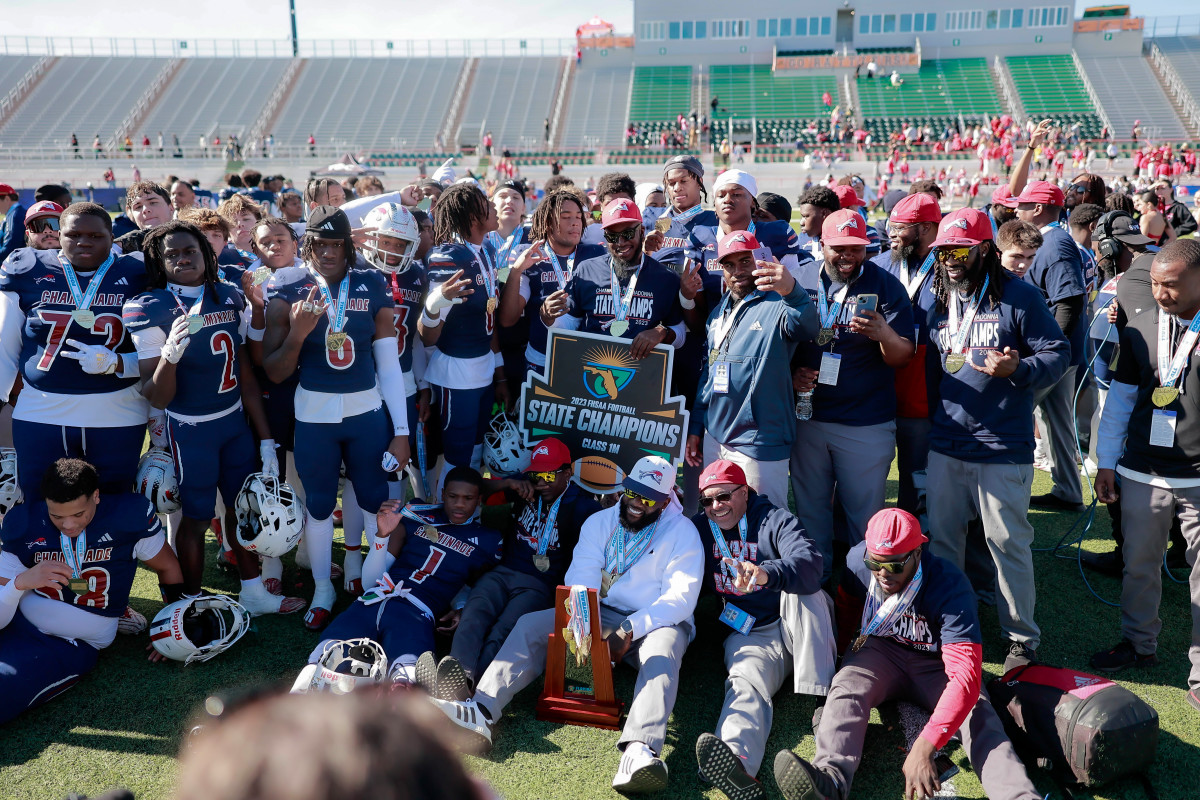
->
xmin=925 ymin=451 xmax=1042 ymax=650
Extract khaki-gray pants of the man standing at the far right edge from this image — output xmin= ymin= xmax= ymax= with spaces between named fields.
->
xmin=1121 ymin=476 xmax=1200 ymax=690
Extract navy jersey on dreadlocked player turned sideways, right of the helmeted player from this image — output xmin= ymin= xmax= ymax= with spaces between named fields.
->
xmin=425 ymin=243 xmax=499 ymax=359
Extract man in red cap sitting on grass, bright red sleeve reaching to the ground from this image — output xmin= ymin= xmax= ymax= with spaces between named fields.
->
xmin=774 ymin=513 xmax=1042 ymax=800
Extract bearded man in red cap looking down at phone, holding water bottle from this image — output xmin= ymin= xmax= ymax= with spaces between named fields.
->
xmin=792 ymin=209 xmax=914 ymax=578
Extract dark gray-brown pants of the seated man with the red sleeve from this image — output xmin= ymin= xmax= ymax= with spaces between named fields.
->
xmin=812 ymin=638 xmax=1042 ymax=800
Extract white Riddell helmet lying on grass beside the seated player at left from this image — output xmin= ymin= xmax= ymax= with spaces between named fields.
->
xmin=150 ymin=595 xmax=250 ymax=664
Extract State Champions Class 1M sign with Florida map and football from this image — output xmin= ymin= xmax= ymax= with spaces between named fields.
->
xmin=521 ymin=329 xmax=688 ymax=493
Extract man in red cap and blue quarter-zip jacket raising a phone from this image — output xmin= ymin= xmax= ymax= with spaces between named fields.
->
xmin=686 ymin=230 xmax=817 ymax=506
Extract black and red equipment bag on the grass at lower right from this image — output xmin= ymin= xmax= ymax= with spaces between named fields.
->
xmin=988 ymin=664 xmax=1158 ymax=786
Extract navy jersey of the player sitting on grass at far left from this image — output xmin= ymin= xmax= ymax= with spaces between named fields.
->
xmin=0 ymin=494 xmax=162 ymax=616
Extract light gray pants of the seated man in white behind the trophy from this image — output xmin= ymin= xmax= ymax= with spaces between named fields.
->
xmin=475 ymin=604 xmax=692 ymax=753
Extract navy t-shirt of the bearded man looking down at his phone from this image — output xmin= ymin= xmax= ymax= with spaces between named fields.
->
xmin=793 ymin=261 xmax=913 ymax=426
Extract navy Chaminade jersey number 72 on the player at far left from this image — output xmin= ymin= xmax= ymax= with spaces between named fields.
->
xmin=0 ymin=247 xmax=146 ymax=395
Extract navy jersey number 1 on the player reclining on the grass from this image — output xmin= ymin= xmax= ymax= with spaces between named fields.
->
xmin=388 ymin=509 xmax=503 ymax=618
